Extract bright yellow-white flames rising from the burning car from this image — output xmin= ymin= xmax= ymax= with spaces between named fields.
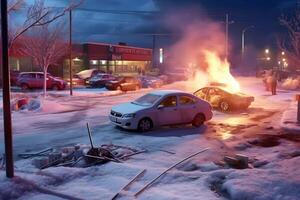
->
xmin=204 ymin=51 xmax=240 ymax=93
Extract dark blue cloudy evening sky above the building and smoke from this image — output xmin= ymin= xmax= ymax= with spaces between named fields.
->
xmin=23 ymin=0 xmax=297 ymax=48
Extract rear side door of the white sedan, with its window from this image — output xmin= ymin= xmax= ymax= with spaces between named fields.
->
xmin=178 ymin=95 xmax=197 ymax=123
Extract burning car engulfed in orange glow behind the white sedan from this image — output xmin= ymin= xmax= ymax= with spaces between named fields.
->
xmin=194 ymin=87 xmax=254 ymax=112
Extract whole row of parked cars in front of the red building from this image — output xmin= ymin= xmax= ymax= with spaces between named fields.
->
xmin=11 ymin=69 xmax=166 ymax=91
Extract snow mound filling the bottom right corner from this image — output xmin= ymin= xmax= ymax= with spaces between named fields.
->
xmin=222 ymin=157 xmax=300 ymax=200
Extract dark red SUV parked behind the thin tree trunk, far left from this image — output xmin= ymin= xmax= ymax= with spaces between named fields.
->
xmin=17 ymin=72 xmax=66 ymax=90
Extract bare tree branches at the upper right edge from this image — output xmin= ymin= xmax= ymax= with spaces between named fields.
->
xmin=277 ymin=4 xmax=300 ymax=69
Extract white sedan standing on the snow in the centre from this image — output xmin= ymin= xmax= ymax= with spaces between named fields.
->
xmin=109 ymin=90 xmax=213 ymax=131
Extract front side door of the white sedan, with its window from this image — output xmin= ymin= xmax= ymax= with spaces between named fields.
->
xmin=157 ymin=95 xmax=182 ymax=125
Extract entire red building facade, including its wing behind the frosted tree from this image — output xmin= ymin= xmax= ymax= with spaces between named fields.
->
xmin=10 ymin=43 xmax=152 ymax=78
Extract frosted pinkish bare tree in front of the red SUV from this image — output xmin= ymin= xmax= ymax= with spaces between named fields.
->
xmin=21 ymin=24 xmax=68 ymax=96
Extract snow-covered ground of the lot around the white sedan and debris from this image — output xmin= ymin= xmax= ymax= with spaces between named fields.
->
xmin=0 ymin=77 xmax=300 ymax=200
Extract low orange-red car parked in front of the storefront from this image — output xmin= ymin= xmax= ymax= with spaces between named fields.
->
xmin=105 ymin=76 xmax=142 ymax=91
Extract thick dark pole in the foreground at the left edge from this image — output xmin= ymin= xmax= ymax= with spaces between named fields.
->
xmin=1 ymin=0 xmax=14 ymax=178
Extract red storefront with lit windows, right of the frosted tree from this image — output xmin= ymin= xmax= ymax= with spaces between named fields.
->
xmin=64 ymin=43 xmax=152 ymax=77
